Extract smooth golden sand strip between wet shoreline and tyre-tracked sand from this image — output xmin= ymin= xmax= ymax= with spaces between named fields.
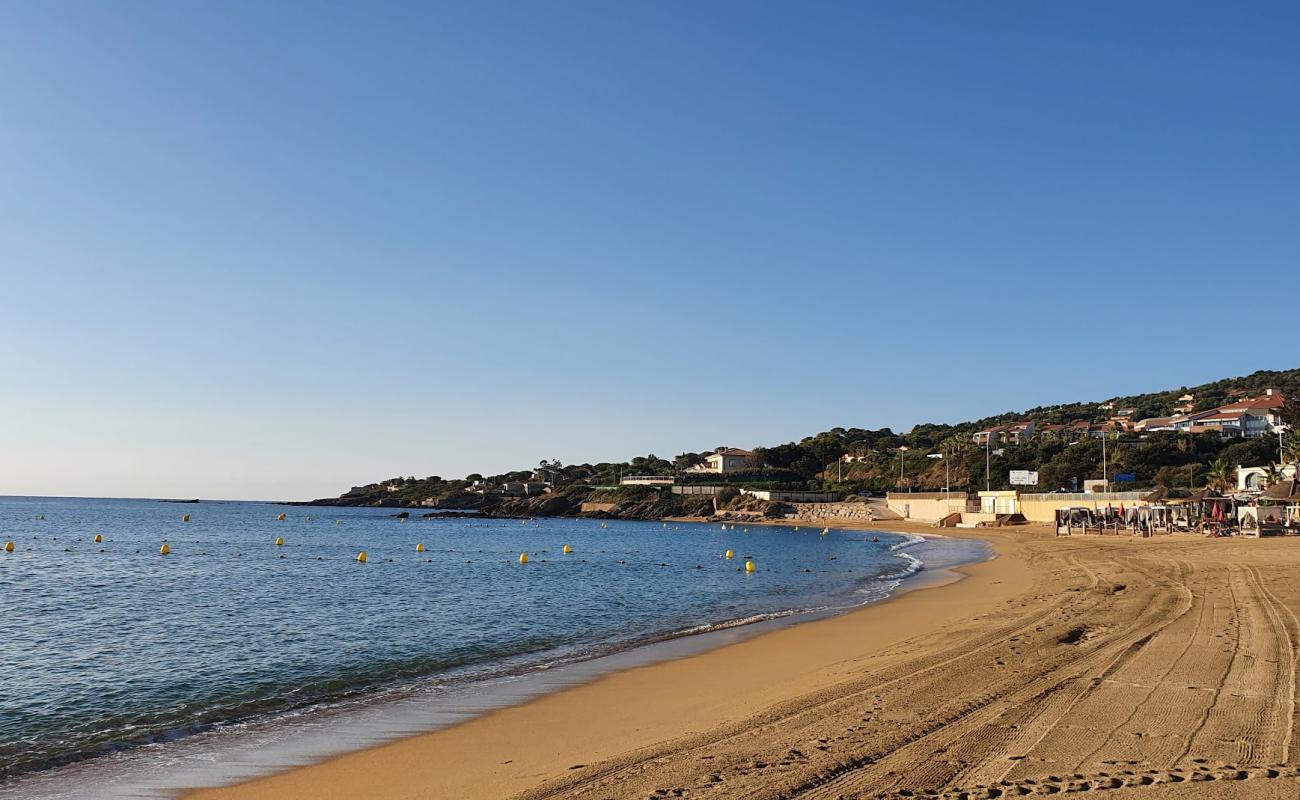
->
xmin=179 ymin=518 xmax=1006 ymax=800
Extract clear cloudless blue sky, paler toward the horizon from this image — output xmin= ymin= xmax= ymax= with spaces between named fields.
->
xmin=0 ymin=0 xmax=1300 ymax=500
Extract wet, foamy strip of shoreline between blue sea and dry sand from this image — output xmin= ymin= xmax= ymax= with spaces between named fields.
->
xmin=0 ymin=519 xmax=991 ymax=800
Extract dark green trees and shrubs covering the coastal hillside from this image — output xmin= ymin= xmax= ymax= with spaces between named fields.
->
xmin=319 ymin=369 xmax=1300 ymax=511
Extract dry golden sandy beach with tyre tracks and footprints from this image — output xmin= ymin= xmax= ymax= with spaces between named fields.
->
xmin=185 ymin=523 xmax=1300 ymax=800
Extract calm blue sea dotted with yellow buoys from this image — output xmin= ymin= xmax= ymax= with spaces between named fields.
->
xmin=0 ymin=498 xmax=979 ymax=780
